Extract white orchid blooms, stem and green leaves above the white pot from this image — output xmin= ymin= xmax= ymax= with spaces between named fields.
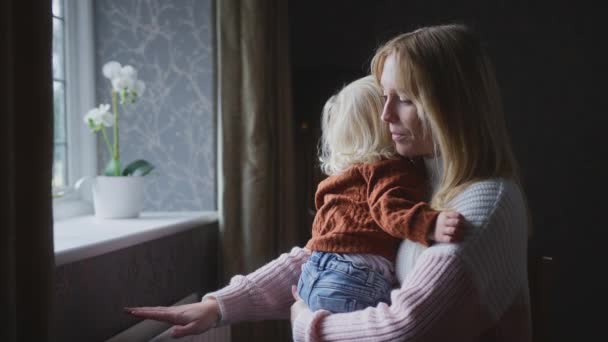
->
xmin=84 ymin=61 xmax=154 ymax=176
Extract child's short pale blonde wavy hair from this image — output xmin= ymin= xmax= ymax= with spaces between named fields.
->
xmin=319 ymin=76 xmax=398 ymax=175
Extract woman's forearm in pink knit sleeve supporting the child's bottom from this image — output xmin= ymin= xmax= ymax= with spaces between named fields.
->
xmin=293 ymin=246 xmax=484 ymax=341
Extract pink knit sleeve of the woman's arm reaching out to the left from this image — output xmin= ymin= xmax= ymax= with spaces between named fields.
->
xmin=204 ymin=247 xmax=310 ymax=325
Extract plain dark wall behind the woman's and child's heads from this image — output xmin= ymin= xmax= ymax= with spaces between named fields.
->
xmin=290 ymin=0 xmax=607 ymax=339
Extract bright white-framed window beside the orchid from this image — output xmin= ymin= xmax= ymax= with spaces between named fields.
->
xmin=52 ymin=0 xmax=97 ymax=218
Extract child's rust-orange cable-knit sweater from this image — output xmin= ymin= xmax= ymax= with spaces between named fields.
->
xmin=306 ymin=158 xmax=439 ymax=261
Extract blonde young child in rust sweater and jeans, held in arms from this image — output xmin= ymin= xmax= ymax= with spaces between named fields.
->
xmin=297 ymin=76 xmax=461 ymax=313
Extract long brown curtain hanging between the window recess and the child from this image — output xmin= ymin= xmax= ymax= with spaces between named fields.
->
xmin=217 ymin=0 xmax=298 ymax=342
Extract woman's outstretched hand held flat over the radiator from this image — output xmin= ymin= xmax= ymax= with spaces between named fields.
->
xmin=125 ymin=298 xmax=220 ymax=337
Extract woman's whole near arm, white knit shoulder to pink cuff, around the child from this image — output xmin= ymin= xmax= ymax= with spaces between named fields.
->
xmin=293 ymin=180 xmax=530 ymax=341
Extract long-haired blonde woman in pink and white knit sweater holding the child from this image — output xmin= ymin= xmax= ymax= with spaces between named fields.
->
xmin=128 ymin=25 xmax=531 ymax=341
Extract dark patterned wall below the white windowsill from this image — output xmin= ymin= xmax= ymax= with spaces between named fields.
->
xmin=52 ymin=223 xmax=218 ymax=342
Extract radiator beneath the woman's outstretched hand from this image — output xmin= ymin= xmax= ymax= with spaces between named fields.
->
xmin=106 ymin=293 xmax=230 ymax=342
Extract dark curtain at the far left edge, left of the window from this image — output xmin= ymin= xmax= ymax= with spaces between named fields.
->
xmin=0 ymin=0 xmax=54 ymax=341
